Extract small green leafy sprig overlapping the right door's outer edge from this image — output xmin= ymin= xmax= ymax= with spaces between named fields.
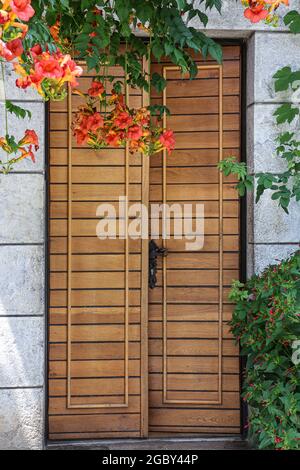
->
xmin=218 ymin=157 xmax=254 ymax=196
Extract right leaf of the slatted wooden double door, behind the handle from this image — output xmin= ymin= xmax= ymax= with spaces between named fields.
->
xmin=149 ymin=46 xmax=240 ymax=436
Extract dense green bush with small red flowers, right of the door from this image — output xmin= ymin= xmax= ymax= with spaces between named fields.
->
xmin=230 ymin=252 xmax=300 ymax=450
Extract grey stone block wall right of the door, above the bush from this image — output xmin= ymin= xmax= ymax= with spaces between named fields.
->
xmin=247 ymin=31 xmax=300 ymax=274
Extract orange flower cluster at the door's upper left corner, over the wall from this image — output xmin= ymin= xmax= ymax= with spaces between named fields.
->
xmin=14 ymin=45 xmax=82 ymax=100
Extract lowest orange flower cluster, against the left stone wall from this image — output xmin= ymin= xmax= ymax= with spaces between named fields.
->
xmin=0 ymin=129 xmax=39 ymax=173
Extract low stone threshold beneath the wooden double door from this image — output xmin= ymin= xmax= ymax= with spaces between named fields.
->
xmin=46 ymin=436 xmax=249 ymax=450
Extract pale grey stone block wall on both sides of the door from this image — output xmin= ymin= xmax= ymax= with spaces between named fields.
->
xmin=0 ymin=0 xmax=300 ymax=449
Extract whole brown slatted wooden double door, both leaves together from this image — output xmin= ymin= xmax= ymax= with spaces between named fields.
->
xmin=48 ymin=46 xmax=240 ymax=440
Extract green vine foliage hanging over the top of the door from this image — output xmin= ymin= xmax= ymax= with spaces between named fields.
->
xmin=26 ymin=0 xmax=222 ymax=92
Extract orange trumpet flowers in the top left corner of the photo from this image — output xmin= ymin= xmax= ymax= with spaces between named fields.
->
xmin=0 ymin=0 xmax=35 ymax=61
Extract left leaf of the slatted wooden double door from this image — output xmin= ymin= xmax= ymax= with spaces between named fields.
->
xmin=49 ymin=64 xmax=147 ymax=439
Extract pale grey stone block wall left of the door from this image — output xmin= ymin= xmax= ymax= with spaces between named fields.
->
xmin=0 ymin=66 xmax=45 ymax=449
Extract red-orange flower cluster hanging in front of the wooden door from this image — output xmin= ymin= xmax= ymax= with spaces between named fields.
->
xmin=72 ymin=81 xmax=175 ymax=155
